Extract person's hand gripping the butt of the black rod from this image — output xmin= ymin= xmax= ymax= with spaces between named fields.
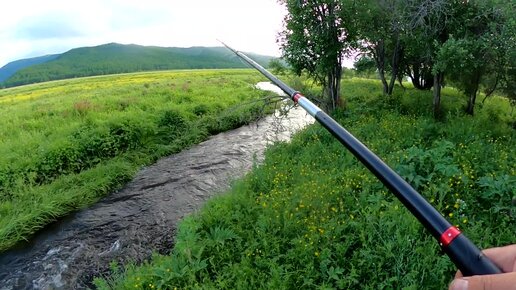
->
xmin=448 ymin=244 xmax=516 ymax=290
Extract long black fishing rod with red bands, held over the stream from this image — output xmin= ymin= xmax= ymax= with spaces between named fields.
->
xmin=221 ymin=42 xmax=502 ymax=276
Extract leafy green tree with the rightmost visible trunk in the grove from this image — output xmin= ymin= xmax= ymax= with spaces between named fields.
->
xmin=434 ymin=1 xmax=514 ymax=115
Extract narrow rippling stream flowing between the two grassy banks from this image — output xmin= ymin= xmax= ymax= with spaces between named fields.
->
xmin=0 ymin=83 xmax=313 ymax=290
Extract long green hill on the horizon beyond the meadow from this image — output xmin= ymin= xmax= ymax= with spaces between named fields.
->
xmin=3 ymin=43 xmax=271 ymax=87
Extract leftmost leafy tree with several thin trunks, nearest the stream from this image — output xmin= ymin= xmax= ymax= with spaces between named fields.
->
xmin=278 ymin=0 xmax=354 ymax=109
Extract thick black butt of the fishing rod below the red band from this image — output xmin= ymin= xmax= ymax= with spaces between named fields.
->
xmin=443 ymin=234 xmax=502 ymax=276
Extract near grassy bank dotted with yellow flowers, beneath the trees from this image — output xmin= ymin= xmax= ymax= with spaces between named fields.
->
xmin=96 ymin=79 xmax=516 ymax=289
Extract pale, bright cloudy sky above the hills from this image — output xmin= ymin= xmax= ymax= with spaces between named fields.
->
xmin=0 ymin=0 xmax=285 ymax=67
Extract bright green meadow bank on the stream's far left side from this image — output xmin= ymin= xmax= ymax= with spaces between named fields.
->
xmin=0 ymin=70 xmax=269 ymax=252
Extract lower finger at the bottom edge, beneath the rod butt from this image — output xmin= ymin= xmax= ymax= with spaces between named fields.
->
xmin=449 ymin=272 xmax=516 ymax=290
